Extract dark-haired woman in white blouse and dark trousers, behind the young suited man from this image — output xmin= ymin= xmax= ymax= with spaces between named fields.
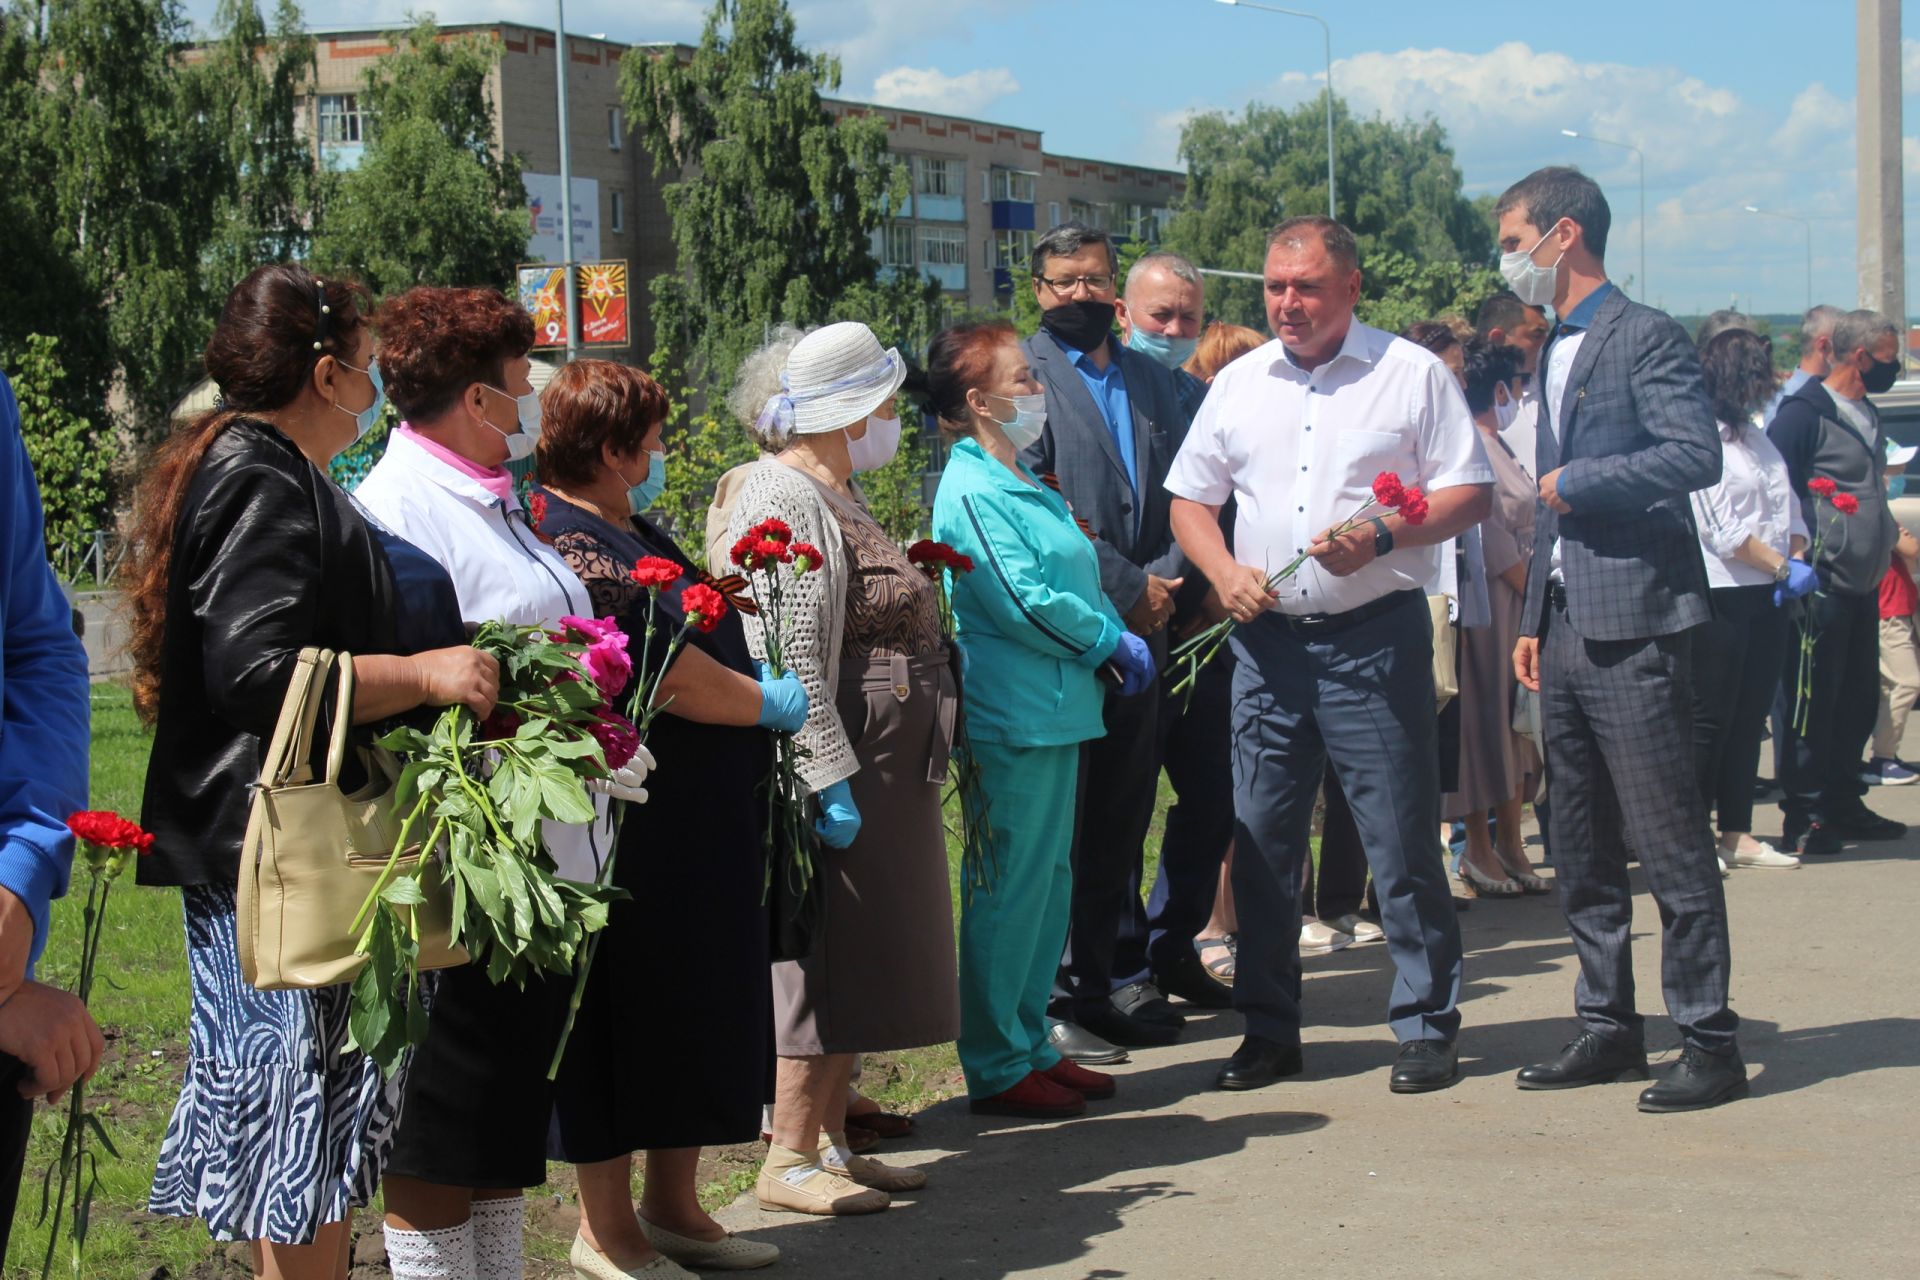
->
xmin=1693 ymin=328 xmax=1816 ymax=871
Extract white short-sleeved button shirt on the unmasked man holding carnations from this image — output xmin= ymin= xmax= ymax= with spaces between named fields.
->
xmin=1167 ymin=320 xmax=1494 ymax=614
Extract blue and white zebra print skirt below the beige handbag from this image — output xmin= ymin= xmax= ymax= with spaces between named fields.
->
xmin=148 ymin=885 xmax=405 ymax=1244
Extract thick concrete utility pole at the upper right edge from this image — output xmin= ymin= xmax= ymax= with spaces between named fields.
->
xmin=1855 ymin=0 xmax=1907 ymax=351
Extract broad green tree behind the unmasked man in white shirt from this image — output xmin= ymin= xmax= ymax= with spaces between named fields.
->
xmin=1165 ymin=98 xmax=1494 ymax=328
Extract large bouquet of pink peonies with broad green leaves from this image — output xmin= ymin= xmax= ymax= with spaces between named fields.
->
xmin=348 ymin=618 xmax=639 ymax=1071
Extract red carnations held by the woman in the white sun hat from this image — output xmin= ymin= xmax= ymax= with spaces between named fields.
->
xmin=728 ymin=518 xmax=826 ymax=913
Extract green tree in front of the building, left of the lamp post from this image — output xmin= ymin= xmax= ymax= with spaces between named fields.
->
xmin=313 ymin=17 xmax=526 ymax=296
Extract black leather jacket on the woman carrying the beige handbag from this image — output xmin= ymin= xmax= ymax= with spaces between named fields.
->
xmin=138 ymin=418 xmax=397 ymax=885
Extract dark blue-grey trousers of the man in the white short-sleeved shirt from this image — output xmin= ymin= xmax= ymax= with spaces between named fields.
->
xmin=1233 ymin=591 xmax=1461 ymax=1044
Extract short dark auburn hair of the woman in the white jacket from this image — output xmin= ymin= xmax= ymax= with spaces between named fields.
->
xmin=378 ymin=284 xmax=534 ymax=422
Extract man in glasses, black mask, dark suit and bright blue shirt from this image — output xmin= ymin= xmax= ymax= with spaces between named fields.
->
xmin=1023 ymin=223 xmax=1188 ymax=1063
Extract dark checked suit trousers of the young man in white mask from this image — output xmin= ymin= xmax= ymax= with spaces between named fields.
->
xmin=1540 ymin=608 xmax=1740 ymax=1054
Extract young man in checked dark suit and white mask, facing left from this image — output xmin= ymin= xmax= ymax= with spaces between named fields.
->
xmin=1494 ymin=169 xmax=1747 ymax=1111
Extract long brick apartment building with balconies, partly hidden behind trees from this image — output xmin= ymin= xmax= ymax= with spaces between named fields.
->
xmin=289 ymin=21 xmax=1185 ymax=363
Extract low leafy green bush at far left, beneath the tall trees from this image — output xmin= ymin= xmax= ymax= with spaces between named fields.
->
xmin=10 ymin=334 xmax=113 ymax=570
